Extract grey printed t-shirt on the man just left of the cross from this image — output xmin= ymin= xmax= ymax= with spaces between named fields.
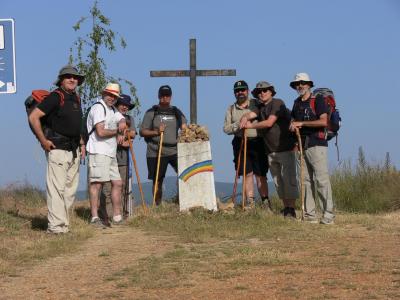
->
xmin=140 ymin=107 xmax=187 ymax=157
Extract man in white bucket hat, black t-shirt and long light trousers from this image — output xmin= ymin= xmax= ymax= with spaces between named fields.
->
xmin=290 ymin=73 xmax=334 ymax=225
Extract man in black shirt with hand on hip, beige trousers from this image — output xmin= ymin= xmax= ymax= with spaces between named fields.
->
xmin=29 ymin=65 xmax=85 ymax=234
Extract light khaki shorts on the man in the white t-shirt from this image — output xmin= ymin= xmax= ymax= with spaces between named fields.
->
xmin=88 ymin=153 xmax=121 ymax=182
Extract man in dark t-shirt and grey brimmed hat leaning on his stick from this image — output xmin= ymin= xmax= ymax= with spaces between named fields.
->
xmin=240 ymin=81 xmax=299 ymax=218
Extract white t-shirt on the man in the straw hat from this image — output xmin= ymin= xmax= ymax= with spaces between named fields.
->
xmin=86 ymin=100 xmax=124 ymax=157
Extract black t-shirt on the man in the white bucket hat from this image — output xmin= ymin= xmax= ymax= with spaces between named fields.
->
xmin=292 ymin=95 xmax=329 ymax=148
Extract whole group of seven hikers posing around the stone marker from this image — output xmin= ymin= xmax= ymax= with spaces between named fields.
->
xmin=29 ymin=65 xmax=334 ymax=234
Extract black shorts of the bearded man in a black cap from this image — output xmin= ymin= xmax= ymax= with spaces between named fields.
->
xmin=232 ymin=137 xmax=268 ymax=176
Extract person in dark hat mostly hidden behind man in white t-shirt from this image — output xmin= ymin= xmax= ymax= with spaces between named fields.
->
xmin=99 ymin=94 xmax=136 ymax=225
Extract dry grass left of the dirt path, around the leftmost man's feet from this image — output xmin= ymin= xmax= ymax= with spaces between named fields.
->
xmin=0 ymin=185 xmax=92 ymax=275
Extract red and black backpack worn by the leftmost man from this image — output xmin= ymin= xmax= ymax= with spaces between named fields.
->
xmin=24 ymin=89 xmax=80 ymax=137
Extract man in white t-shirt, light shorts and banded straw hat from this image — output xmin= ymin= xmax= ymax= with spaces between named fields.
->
xmin=86 ymin=83 xmax=126 ymax=228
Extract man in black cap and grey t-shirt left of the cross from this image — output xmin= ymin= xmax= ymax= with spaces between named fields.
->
xmin=139 ymin=85 xmax=187 ymax=205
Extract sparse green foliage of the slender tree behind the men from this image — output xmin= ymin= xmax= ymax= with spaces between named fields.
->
xmin=69 ymin=1 xmax=140 ymax=115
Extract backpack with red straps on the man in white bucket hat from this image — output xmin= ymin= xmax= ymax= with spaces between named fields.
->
xmin=310 ymin=88 xmax=342 ymax=141
